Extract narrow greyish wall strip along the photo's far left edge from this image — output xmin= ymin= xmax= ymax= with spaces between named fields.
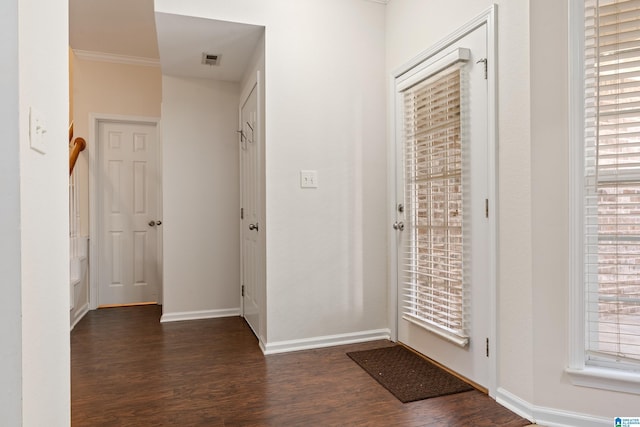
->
xmin=0 ymin=0 xmax=22 ymax=426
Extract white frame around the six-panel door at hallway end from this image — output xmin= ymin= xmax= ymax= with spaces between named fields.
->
xmin=87 ymin=113 xmax=162 ymax=310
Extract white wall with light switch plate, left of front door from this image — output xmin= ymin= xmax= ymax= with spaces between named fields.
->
xmin=155 ymin=0 xmax=388 ymax=344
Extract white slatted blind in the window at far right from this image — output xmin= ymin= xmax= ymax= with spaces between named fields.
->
xmin=584 ymin=0 xmax=640 ymax=369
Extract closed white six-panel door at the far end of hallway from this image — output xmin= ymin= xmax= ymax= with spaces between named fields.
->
xmin=98 ymin=122 xmax=162 ymax=306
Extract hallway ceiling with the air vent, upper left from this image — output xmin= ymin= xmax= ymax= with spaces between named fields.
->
xmin=69 ymin=0 xmax=264 ymax=82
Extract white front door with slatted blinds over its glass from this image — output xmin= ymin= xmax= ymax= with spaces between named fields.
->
xmin=394 ymin=20 xmax=491 ymax=387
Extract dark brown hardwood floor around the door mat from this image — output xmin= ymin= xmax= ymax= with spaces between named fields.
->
xmin=71 ymin=306 xmax=529 ymax=427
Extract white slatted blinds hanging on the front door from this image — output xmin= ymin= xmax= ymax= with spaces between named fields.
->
xmin=401 ymin=63 xmax=468 ymax=346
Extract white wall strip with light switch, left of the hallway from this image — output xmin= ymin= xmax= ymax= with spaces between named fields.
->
xmin=17 ymin=0 xmax=70 ymax=426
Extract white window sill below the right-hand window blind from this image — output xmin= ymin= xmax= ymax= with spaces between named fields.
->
xmin=566 ymin=366 xmax=640 ymax=394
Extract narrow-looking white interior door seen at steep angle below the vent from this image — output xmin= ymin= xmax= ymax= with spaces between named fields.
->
xmin=240 ymin=85 xmax=262 ymax=336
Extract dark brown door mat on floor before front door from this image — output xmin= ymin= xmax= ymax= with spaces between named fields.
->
xmin=347 ymin=345 xmax=474 ymax=403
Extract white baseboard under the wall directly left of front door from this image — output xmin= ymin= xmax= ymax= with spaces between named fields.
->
xmin=260 ymin=329 xmax=391 ymax=355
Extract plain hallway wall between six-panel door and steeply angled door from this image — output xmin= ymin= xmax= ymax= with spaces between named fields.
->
xmin=161 ymin=76 xmax=240 ymax=320
